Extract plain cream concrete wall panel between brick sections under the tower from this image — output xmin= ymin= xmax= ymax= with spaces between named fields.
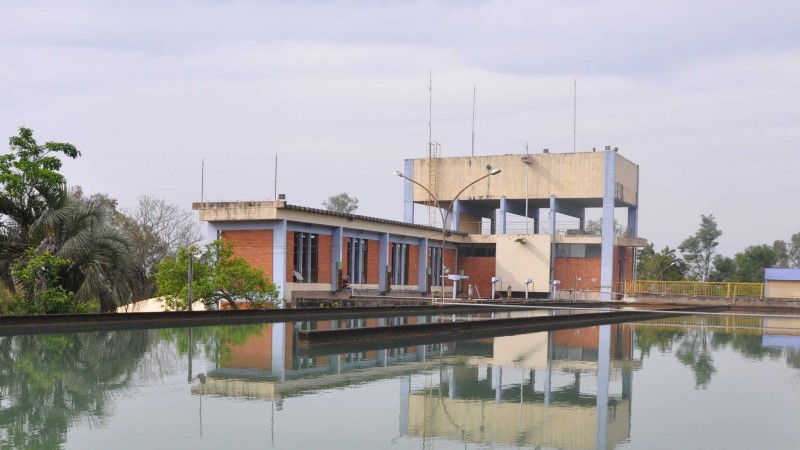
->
xmin=496 ymin=234 xmax=550 ymax=292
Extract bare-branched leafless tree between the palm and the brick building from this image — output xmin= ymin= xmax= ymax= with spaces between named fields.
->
xmin=120 ymin=196 xmax=201 ymax=300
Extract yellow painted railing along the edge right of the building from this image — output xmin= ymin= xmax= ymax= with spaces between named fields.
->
xmin=617 ymin=280 xmax=764 ymax=299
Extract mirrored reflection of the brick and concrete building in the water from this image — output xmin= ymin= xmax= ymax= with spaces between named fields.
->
xmin=192 ymin=317 xmax=641 ymax=449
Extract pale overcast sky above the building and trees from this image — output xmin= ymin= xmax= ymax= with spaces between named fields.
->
xmin=0 ymin=0 xmax=800 ymax=256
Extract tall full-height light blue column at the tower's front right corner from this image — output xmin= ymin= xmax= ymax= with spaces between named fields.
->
xmin=600 ymin=152 xmax=617 ymax=302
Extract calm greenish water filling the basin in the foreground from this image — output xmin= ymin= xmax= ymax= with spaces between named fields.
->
xmin=0 ymin=313 xmax=800 ymax=450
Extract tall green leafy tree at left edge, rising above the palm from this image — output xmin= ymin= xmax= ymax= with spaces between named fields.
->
xmin=0 ymin=127 xmax=80 ymax=293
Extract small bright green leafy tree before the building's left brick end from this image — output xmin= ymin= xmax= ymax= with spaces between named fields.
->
xmin=156 ymin=240 xmax=279 ymax=310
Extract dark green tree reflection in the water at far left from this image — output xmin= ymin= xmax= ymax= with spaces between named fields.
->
xmin=0 ymin=330 xmax=150 ymax=449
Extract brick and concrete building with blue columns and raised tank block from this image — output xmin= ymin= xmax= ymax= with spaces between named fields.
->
xmin=193 ymin=151 xmax=646 ymax=300
